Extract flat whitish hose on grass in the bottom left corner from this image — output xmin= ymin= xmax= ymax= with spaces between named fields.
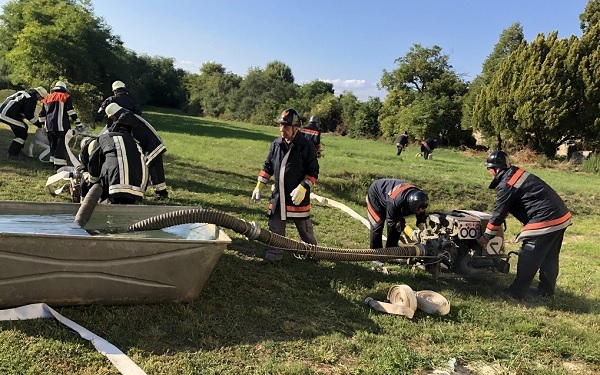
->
xmin=0 ymin=303 xmax=146 ymax=375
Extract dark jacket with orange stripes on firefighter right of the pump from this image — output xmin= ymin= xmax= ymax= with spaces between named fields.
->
xmin=484 ymin=167 xmax=572 ymax=241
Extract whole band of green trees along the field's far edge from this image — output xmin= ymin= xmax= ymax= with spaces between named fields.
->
xmin=0 ymin=0 xmax=600 ymax=156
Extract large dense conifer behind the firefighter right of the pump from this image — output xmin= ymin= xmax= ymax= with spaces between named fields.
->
xmin=474 ymin=32 xmax=584 ymax=158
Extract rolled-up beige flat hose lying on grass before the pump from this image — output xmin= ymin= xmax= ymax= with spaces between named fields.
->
xmin=365 ymin=284 xmax=450 ymax=319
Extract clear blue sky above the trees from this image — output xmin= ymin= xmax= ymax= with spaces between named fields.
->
xmin=5 ymin=0 xmax=587 ymax=101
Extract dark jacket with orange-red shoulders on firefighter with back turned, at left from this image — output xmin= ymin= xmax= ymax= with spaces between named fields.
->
xmin=39 ymin=89 xmax=77 ymax=132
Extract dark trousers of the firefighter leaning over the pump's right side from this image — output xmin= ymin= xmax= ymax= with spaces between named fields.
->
xmin=509 ymin=229 xmax=566 ymax=298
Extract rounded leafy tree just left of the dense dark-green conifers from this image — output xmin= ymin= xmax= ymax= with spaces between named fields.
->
xmin=379 ymin=44 xmax=467 ymax=144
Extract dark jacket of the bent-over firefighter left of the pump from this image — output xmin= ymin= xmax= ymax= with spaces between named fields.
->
xmin=367 ymin=178 xmax=427 ymax=228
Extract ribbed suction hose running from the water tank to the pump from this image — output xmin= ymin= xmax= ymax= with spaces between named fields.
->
xmin=110 ymin=208 xmax=427 ymax=261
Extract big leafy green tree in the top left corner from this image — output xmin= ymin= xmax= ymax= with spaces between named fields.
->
xmin=0 ymin=0 xmax=121 ymax=86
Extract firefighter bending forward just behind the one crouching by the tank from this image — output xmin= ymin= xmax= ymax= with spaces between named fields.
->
xmin=106 ymin=103 xmax=169 ymax=200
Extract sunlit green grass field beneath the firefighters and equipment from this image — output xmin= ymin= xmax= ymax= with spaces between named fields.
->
xmin=0 ymin=108 xmax=600 ymax=375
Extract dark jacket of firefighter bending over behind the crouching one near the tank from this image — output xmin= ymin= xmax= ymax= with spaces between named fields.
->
xmin=109 ymin=109 xmax=167 ymax=165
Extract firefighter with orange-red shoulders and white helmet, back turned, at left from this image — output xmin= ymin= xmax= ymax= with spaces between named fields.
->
xmin=40 ymin=81 xmax=81 ymax=170
